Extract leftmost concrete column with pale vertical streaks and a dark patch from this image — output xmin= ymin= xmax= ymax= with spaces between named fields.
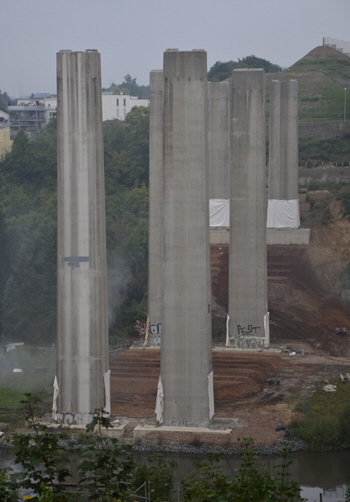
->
xmin=57 ymin=50 xmax=108 ymax=413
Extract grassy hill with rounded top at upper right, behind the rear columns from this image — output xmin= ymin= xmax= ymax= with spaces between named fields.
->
xmin=265 ymin=46 xmax=350 ymax=122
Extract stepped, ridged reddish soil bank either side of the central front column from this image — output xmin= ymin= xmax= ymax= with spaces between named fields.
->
xmin=110 ymin=349 xmax=290 ymax=418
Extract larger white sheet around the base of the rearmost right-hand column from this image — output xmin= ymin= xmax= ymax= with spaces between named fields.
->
xmin=267 ymin=199 xmax=300 ymax=228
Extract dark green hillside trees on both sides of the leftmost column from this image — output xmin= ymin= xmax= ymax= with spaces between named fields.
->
xmin=0 ymin=107 xmax=149 ymax=343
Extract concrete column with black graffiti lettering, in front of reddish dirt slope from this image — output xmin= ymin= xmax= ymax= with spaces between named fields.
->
xmin=229 ymin=69 xmax=267 ymax=344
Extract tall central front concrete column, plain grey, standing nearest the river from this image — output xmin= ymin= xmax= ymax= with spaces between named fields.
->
xmin=161 ymin=50 xmax=212 ymax=426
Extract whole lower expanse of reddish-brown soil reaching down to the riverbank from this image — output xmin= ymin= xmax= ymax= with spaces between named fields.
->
xmin=110 ymin=349 xmax=349 ymax=448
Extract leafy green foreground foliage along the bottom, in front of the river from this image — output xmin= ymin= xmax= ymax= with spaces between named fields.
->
xmin=0 ymin=423 xmax=305 ymax=502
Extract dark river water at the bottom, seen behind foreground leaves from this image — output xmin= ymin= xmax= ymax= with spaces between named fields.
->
xmin=0 ymin=450 xmax=350 ymax=502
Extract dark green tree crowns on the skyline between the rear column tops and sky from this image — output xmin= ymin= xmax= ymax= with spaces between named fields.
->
xmin=208 ymin=56 xmax=282 ymax=82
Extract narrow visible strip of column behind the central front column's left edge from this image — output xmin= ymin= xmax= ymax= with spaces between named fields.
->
xmin=148 ymin=70 xmax=164 ymax=330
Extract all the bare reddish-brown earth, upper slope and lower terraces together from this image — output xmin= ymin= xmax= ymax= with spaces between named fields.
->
xmin=110 ymin=194 xmax=350 ymax=448
